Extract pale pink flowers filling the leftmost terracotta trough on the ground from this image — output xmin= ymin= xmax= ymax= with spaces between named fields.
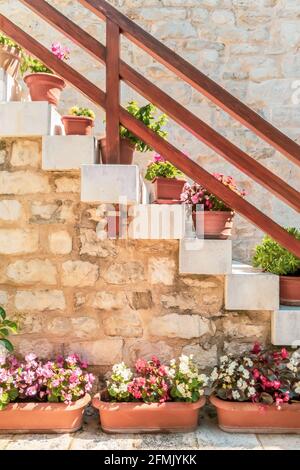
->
xmin=0 ymin=354 xmax=94 ymax=410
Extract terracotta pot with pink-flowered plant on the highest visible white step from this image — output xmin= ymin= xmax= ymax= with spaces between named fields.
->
xmin=23 ymin=43 xmax=70 ymax=106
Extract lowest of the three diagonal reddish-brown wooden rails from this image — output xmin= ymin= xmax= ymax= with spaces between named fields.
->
xmin=0 ymin=15 xmax=300 ymax=257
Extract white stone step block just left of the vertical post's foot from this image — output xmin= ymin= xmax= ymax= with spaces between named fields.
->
xmin=42 ymin=135 xmax=99 ymax=171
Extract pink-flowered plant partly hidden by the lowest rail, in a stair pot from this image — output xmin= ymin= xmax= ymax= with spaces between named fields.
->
xmin=180 ymin=173 xmax=246 ymax=211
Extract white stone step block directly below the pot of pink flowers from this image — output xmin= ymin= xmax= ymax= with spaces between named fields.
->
xmin=179 ymin=238 xmax=232 ymax=275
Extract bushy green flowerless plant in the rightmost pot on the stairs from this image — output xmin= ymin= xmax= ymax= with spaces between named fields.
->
xmin=253 ymin=227 xmax=300 ymax=276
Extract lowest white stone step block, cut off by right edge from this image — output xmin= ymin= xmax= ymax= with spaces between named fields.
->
xmin=271 ymin=305 xmax=300 ymax=347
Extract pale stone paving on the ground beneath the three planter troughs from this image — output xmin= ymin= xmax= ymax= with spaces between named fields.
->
xmin=0 ymin=412 xmax=300 ymax=451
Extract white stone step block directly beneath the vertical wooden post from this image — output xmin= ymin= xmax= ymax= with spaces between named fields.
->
xmin=81 ymin=165 xmax=142 ymax=204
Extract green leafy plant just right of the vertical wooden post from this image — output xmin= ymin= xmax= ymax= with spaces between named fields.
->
xmin=120 ymin=101 xmax=167 ymax=152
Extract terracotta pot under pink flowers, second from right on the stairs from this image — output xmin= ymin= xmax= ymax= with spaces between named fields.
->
xmin=193 ymin=211 xmax=234 ymax=240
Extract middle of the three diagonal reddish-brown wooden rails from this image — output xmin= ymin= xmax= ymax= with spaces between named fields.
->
xmin=15 ymin=0 xmax=300 ymax=212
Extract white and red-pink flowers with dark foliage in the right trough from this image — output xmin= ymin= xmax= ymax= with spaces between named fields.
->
xmin=211 ymin=343 xmax=300 ymax=408
